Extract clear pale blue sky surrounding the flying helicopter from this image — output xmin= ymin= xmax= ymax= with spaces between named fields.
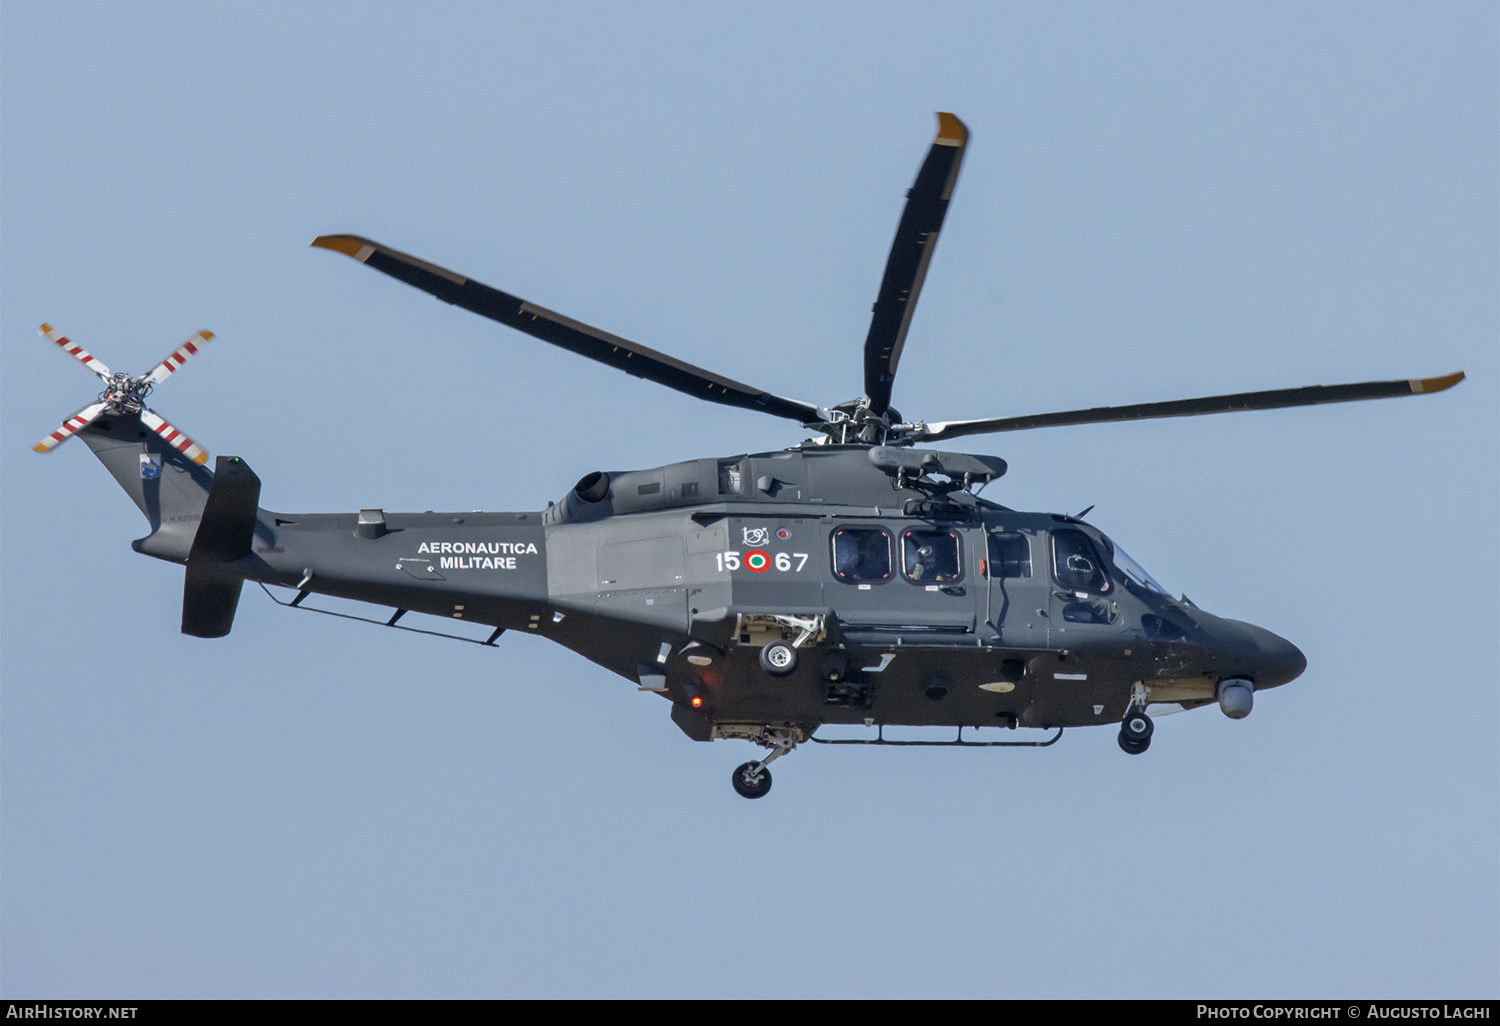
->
xmin=0 ymin=0 xmax=1500 ymax=998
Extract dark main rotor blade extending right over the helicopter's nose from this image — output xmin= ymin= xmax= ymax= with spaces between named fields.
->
xmin=914 ymin=371 xmax=1464 ymax=441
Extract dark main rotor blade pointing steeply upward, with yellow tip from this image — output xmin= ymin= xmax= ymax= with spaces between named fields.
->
xmin=864 ymin=113 xmax=969 ymax=414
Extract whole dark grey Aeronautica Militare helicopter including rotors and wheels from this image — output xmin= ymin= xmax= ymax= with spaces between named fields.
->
xmin=35 ymin=113 xmax=1464 ymax=798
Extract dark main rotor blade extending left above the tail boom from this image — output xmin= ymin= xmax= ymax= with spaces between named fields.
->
xmin=312 ymin=236 xmax=824 ymax=425
